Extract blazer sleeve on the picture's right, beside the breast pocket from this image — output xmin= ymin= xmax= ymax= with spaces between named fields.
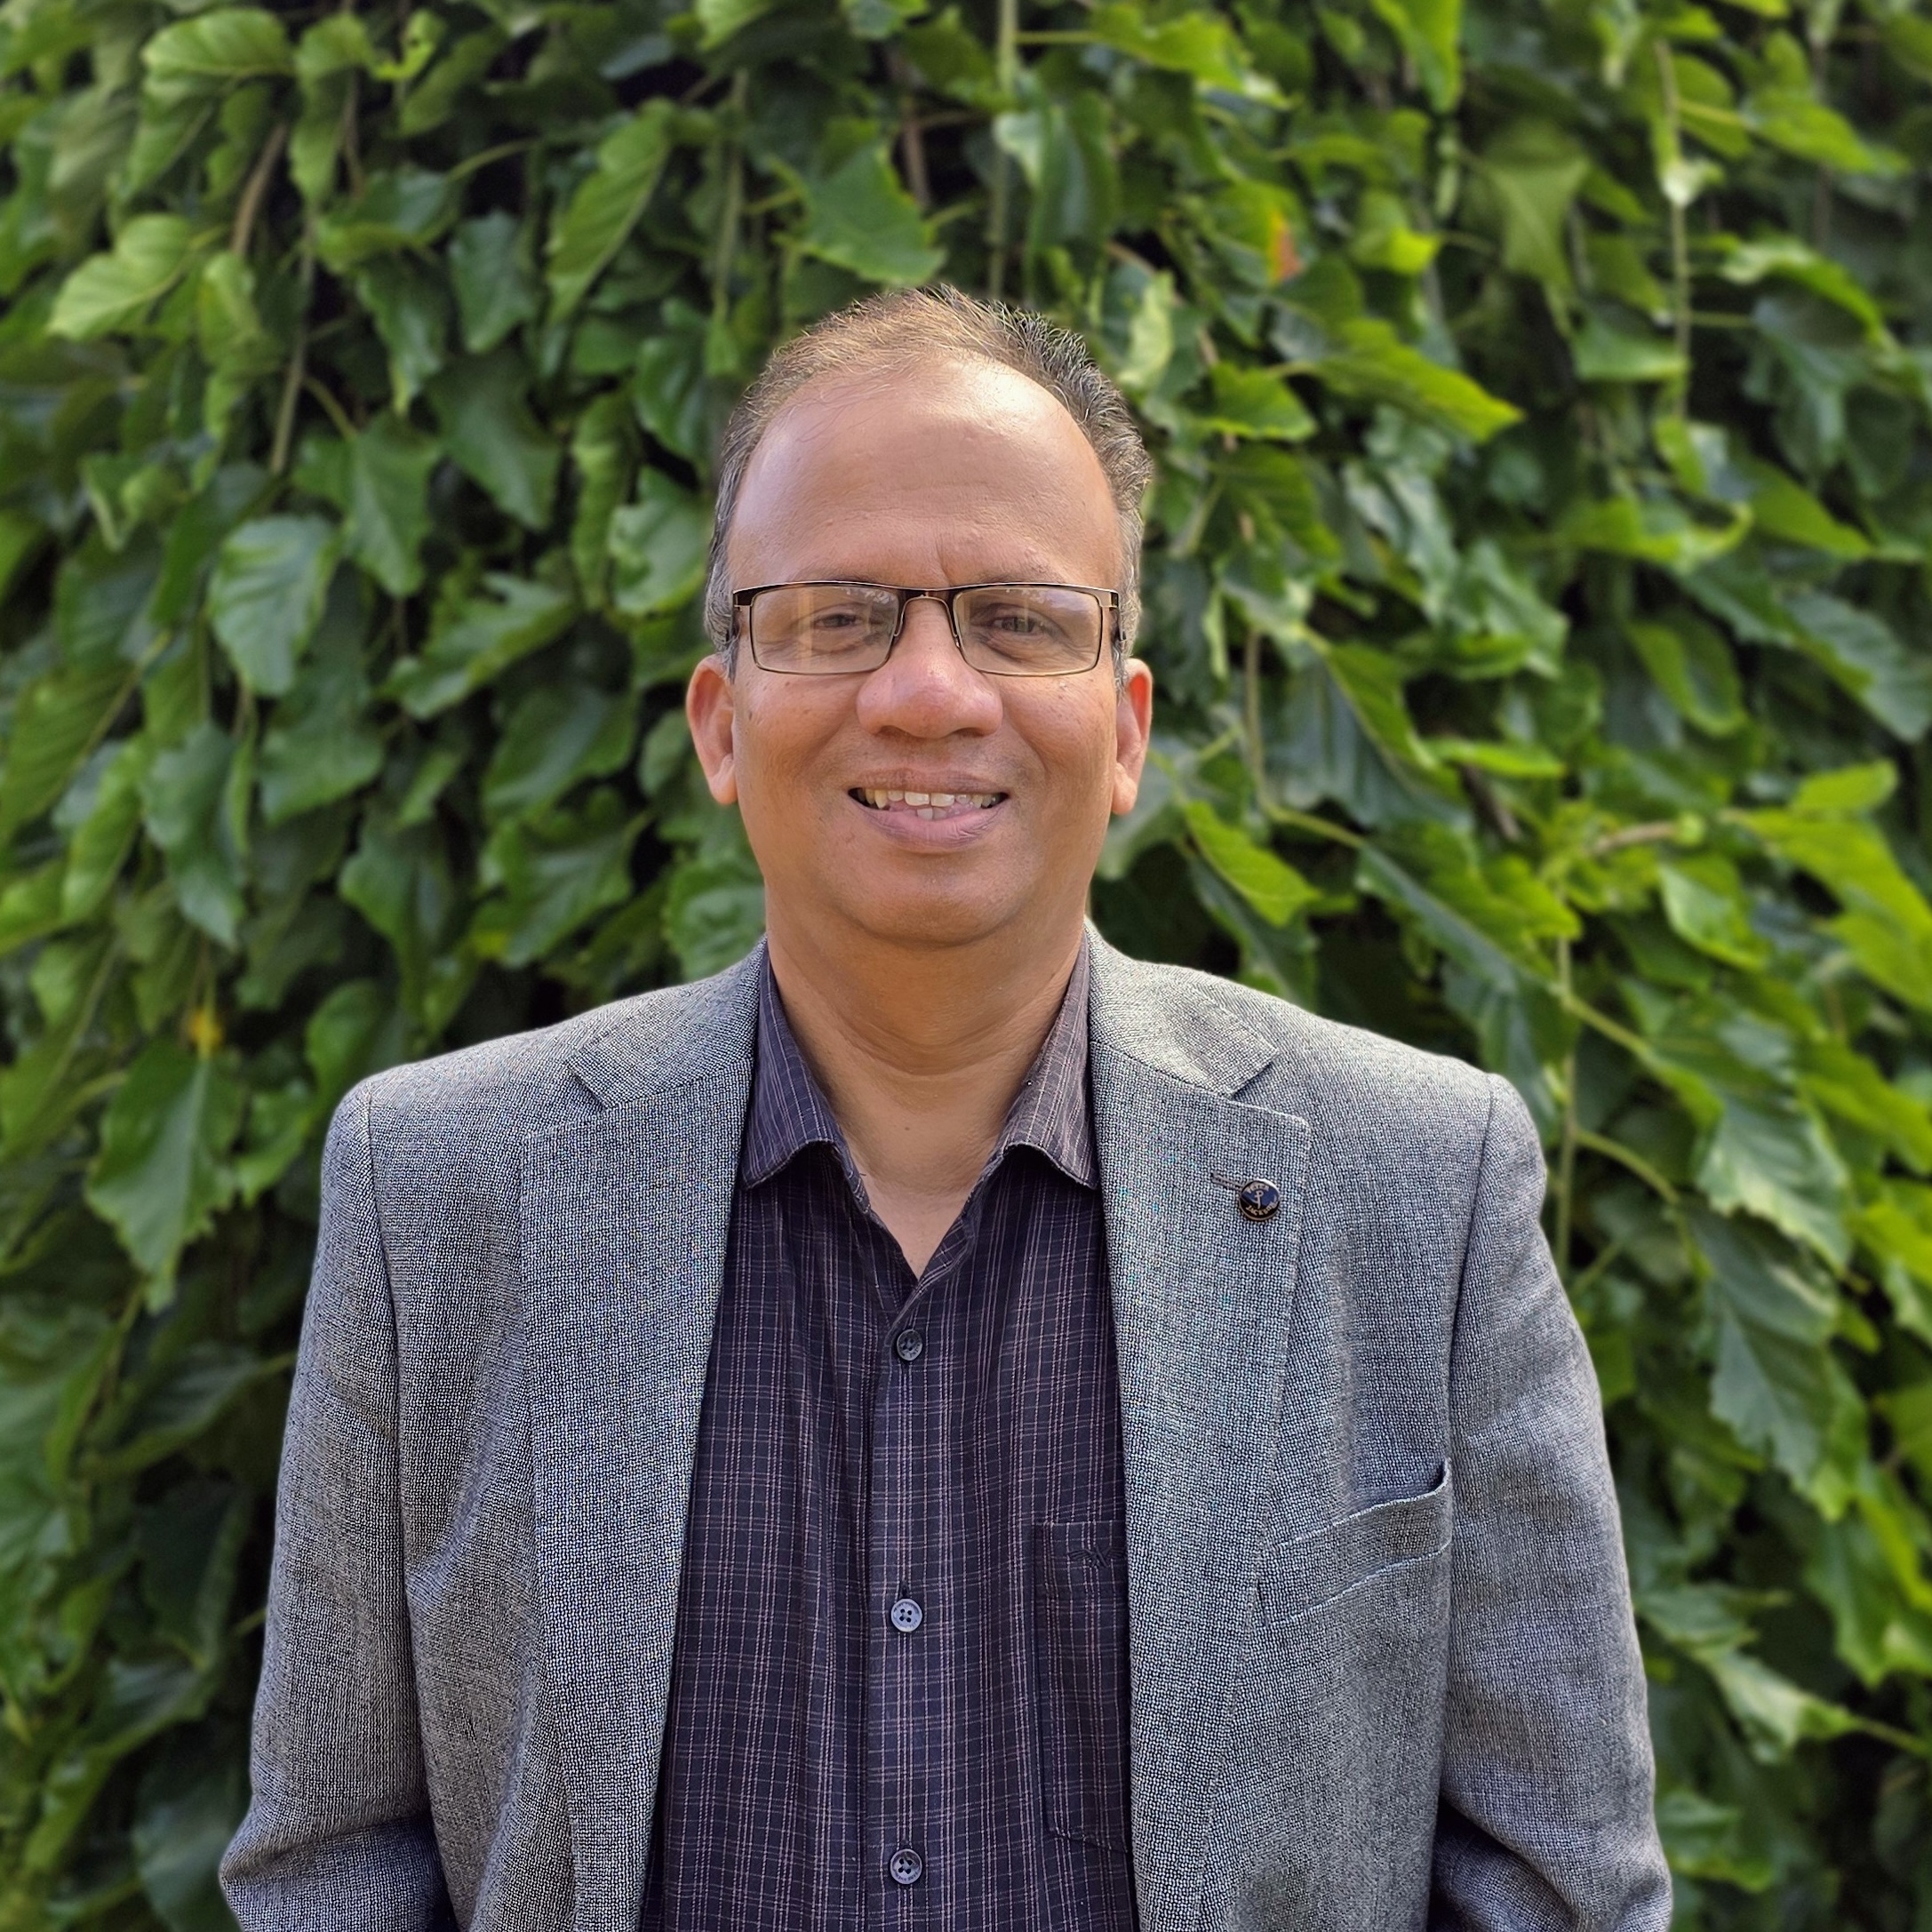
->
xmin=1430 ymin=1076 xmax=1672 ymax=1932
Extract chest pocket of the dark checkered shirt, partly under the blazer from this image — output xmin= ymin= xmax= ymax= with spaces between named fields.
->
xmin=1034 ymin=1522 xmax=1129 ymax=1853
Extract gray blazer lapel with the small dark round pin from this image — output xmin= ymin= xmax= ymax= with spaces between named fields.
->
xmin=1090 ymin=941 xmax=1308 ymax=1932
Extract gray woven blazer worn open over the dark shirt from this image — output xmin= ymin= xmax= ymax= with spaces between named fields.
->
xmin=222 ymin=941 xmax=1669 ymax=1932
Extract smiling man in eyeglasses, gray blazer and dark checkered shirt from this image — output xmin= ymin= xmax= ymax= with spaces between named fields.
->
xmin=224 ymin=290 xmax=1669 ymax=1932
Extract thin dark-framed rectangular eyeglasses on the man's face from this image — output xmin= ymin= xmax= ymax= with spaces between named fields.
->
xmin=732 ymin=584 xmax=1121 ymax=678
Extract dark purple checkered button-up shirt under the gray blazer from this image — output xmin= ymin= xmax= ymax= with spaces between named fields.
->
xmin=643 ymin=948 xmax=1134 ymax=1932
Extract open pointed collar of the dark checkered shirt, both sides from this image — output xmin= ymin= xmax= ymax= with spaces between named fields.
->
xmin=738 ymin=937 xmax=1099 ymax=1192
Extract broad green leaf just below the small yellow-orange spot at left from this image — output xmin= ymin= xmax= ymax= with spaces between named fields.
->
xmin=87 ymin=1040 xmax=242 ymax=1281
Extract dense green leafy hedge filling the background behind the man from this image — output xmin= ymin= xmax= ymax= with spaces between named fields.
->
xmin=0 ymin=0 xmax=1932 ymax=1908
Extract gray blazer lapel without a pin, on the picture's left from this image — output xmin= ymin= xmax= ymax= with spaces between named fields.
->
xmin=522 ymin=953 xmax=762 ymax=1932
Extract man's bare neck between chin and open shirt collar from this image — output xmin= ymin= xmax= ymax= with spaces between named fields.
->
xmin=767 ymin=906 xmax=1082 ymax=1273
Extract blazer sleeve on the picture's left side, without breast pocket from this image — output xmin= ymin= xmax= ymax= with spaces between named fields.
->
xmin=220 ymin=1084 xmax=456 ymax=1932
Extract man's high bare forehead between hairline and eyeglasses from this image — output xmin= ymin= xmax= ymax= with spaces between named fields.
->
xmin=729 ymin=362 xmax=1121 ymax=586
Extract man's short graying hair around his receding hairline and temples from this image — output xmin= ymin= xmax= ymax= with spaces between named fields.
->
xmin=706 ymin=282 xmax=1154 ymax=667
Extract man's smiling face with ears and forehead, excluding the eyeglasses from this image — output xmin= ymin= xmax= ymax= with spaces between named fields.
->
xmin=688 ymin=363 xmax=1152 ymax=946
